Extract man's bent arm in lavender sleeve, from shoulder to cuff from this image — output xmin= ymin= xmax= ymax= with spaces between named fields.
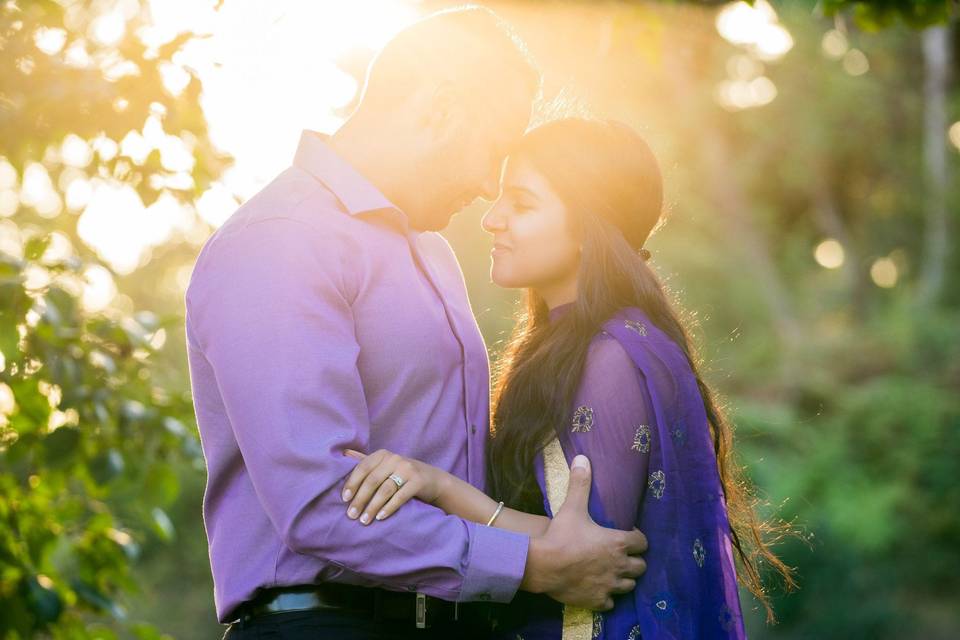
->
xmin=187 ymin=218 xmax=528 ymax=601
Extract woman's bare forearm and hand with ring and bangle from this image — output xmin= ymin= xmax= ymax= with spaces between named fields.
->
xmin=343 ymin=449 xmax=550 ymax=537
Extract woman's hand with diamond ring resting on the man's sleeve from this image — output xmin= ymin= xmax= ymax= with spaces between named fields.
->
xmin=341 ymin=449 xmax=449 ymax=525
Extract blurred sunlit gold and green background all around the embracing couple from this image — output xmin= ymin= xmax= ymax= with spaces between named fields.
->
xmin=0 ymin=0 xmax=960 ymax=639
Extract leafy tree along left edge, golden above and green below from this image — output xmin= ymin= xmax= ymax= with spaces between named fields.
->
xmin=0 ymin=0 xmax=229 ymax=639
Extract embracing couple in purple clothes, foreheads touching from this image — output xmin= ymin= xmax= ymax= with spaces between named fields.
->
xmin=186 ymin=8 xmax=788 ymax=640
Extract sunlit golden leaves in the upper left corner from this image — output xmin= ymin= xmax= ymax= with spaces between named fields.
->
xmin=0 ymin=0 xmax=229 ymax=205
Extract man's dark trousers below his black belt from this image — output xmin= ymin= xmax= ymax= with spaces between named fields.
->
xmin=223 ymin=609 xmax=490 ymax=640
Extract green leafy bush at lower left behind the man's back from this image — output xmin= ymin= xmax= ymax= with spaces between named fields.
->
xmin=0 ymin=237 xmax=200 ymax=638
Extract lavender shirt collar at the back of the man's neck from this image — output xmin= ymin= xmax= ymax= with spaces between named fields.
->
xmin=293 ymin=129 xmax=400 ymax=215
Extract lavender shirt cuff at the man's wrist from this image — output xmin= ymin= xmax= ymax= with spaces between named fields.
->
xmin=457 ymin=522 xmax=530 ymax=602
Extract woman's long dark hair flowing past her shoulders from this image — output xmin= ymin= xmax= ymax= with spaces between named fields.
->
xmin=487 ymin=118 xmax=795 ymax=621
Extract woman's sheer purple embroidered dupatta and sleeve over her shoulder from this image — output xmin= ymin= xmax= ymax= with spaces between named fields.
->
xmin=520 ymin=308 xmax=746 ymax=640
